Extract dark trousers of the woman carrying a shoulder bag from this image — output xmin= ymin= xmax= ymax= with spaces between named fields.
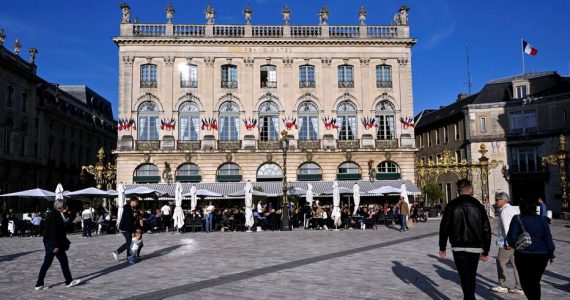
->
xmin=515 ymin=252 xmax=548 ymax=300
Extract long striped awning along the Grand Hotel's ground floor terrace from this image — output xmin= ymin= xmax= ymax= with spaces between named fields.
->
xmin=125 ymin=180 xmax=421 ymax=199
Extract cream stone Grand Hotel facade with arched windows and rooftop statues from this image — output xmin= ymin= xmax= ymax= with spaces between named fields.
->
xmin=114 ymin=4 xmax=416 ymax=188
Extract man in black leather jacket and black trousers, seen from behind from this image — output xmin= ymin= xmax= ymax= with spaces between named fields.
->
xmin=439 ymin=179 xmax=491 ymax=299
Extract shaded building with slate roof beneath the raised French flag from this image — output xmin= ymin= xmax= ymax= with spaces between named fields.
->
xmin=416 ymin=72 xmax=570 ymax=212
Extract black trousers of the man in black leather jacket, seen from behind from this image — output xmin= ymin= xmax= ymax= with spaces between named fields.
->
xmin=453 ymin=251 xmax=481 ymax=300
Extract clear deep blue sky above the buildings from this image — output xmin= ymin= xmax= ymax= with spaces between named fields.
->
xmin=0 ymin=0 xmax=570 ymax=115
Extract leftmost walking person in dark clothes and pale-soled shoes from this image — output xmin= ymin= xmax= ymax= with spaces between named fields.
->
xmin=35 ymin=200 xmax=81 ymax=291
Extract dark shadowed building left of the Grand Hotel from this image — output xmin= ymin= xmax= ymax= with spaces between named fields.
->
xmin=0 ymin=30 xmax=117 ymax=199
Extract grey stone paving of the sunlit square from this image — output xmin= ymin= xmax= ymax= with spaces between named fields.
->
xmin=0 ymin=220 xmax=570 ymax=299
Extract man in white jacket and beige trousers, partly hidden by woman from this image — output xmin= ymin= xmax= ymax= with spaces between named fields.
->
xmin=491 ymin=192 xmax=523 ymax=295
